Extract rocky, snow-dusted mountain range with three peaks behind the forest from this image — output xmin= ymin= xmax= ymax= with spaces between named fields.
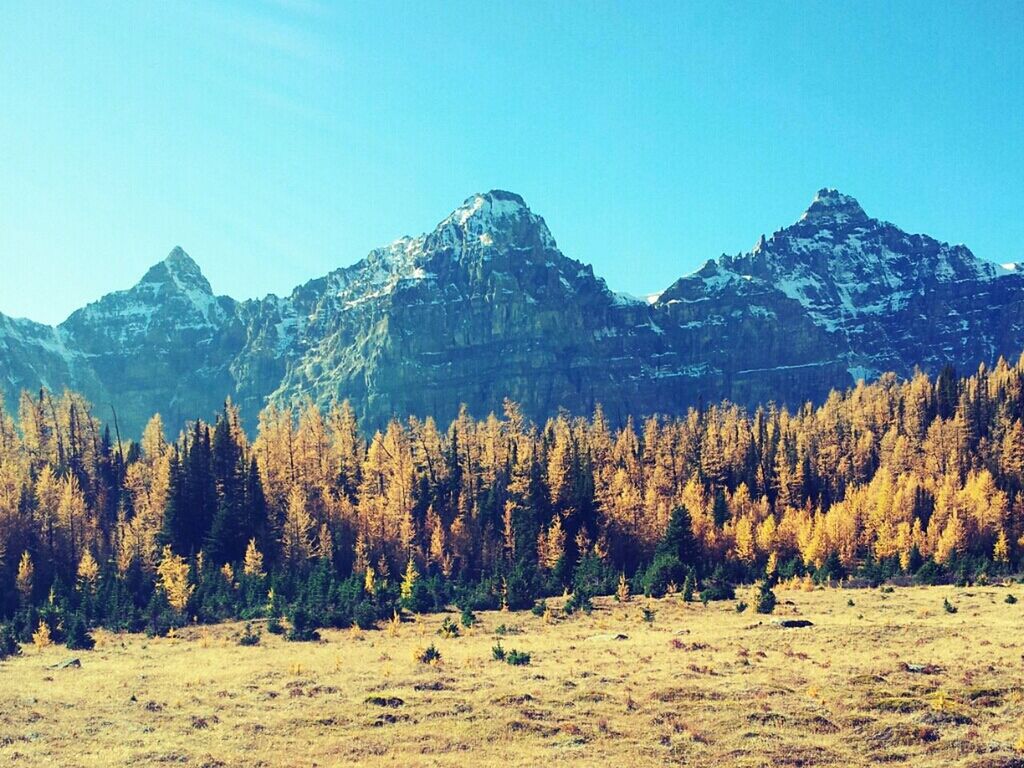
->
xmin=0 ymin=189 xmax=1024 ymax=433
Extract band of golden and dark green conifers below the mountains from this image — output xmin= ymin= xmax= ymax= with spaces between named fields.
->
xmin=0 ymin=358 xmax=1024 ymax=651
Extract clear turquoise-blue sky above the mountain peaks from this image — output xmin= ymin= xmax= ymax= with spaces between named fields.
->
xmin=0 ymin=0 xmax=1024 ymax=323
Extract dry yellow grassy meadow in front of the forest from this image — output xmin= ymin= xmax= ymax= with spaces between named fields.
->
xmin=0 ymin=586 xmax=1024 ymax=768
